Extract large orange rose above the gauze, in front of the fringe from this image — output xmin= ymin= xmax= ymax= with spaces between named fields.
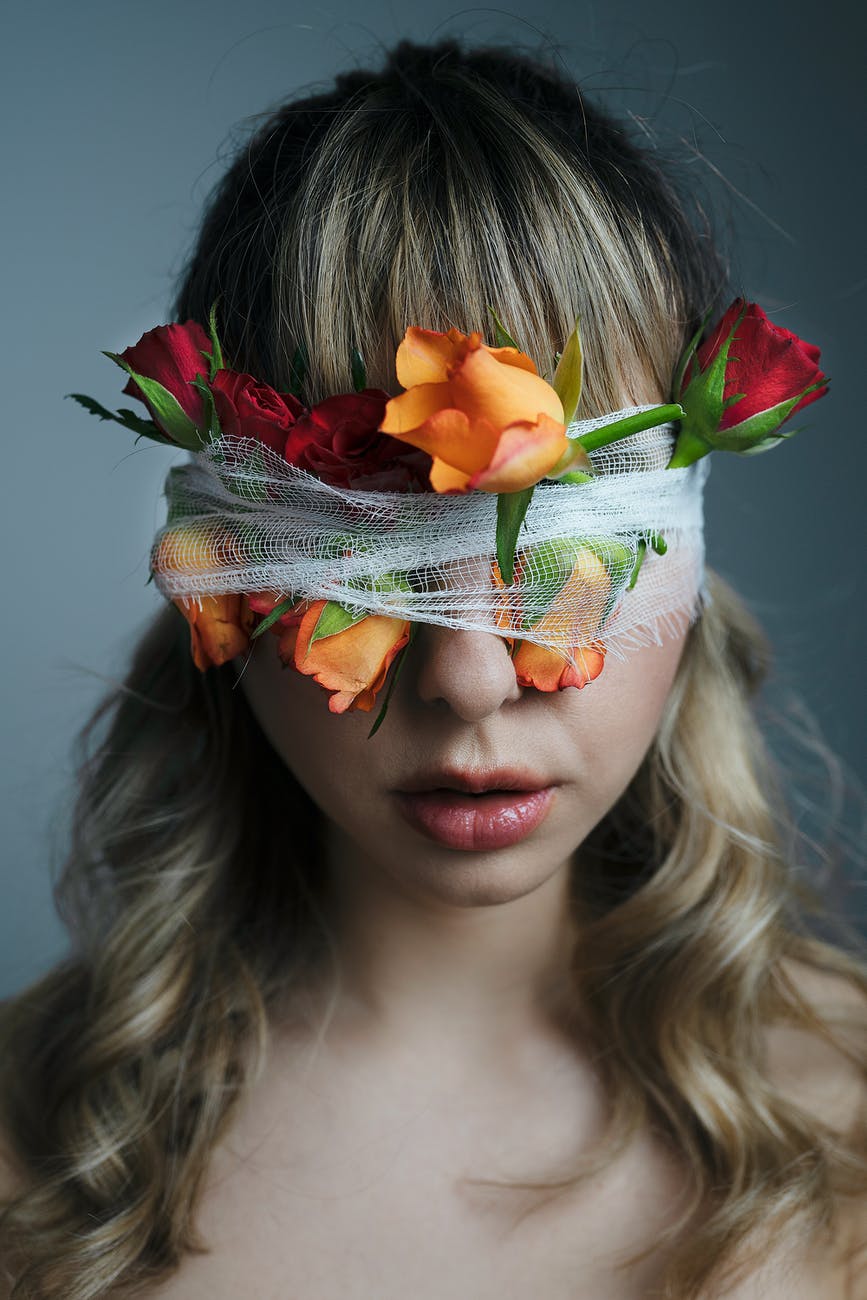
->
xmin=380 ymin=325 xmax=569 ymax=493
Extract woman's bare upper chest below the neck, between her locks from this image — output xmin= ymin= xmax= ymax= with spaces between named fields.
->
xmin=147 ymin=1045 xmax=684 ymax=1300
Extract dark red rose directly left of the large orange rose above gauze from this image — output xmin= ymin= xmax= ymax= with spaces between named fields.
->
xmin=283 ymin=389 xmax=432 ymax=491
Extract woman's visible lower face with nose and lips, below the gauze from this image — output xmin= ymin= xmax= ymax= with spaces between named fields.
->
xmin=235 ymin=624 xmax=684 ymax=907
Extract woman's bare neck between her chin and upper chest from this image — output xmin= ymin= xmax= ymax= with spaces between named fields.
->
xmin=311 ymin=832 xmax=573 ymax=1052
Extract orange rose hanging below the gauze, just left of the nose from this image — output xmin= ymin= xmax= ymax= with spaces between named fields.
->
xmin=295 ymin=601 xmax=409 ymax=714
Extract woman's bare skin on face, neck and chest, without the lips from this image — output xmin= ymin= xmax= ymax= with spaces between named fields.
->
xmin=133 ymin=627 xmax=858 ymax=1300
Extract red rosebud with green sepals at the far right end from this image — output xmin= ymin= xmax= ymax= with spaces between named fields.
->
xmin=669 ymin=298 xmax=828 ymax=468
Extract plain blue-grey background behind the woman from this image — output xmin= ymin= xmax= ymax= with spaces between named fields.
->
xmin=0 ymin=0 xmax=867 ymax=993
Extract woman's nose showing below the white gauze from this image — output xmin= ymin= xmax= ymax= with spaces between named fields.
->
xmin=411 ymin=623 xmax=521 ymax=723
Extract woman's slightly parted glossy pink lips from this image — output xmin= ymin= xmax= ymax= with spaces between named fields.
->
xmin=396 ymin=771 xmax=555 ymax=853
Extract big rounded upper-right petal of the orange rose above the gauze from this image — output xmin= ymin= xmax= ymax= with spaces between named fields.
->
xmin=451 ymin=347 xmax=563 ymax=430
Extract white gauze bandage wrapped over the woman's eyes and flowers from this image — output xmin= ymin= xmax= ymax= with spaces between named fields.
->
xmin=151 ymin=407 xmax=707 ymax=658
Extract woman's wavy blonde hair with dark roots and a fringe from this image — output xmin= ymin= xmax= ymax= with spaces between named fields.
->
xmin=0 ymin=44 xmax=867 ymax=1300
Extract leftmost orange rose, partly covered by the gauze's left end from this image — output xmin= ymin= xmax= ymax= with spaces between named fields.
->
xmin=151 ymin=527 xmax=253 ymax=672
